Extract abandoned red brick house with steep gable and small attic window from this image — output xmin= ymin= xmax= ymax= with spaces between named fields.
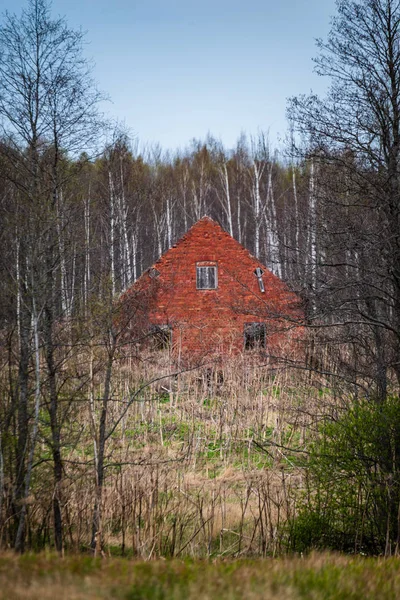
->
xmin=123 ymin=217 xmax=302 ymax=356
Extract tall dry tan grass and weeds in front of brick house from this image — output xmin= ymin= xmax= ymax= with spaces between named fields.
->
xmin=0 ymin=357 xmax=325 ymax=559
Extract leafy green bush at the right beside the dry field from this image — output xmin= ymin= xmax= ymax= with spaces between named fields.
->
xmin=288 ymin=398 xmax=400 ymax=555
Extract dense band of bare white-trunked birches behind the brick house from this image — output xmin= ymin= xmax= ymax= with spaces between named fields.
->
xmin=0 ymin=127 xmax=392 ymax=397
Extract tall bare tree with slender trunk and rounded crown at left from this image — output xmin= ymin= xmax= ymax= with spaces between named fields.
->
xmin=0 ymin=0 xmax=100 ymax=551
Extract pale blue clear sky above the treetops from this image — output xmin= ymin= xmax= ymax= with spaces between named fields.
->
xmin=1 ymin=0 xmax=335 ymax=150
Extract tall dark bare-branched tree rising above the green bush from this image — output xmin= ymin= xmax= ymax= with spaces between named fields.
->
xmin=289 ymin=0 xmax=400 ymax=399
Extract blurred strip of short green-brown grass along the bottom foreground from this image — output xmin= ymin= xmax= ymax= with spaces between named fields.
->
xmin=0 ymin=554 xmax=400 ymax=600
